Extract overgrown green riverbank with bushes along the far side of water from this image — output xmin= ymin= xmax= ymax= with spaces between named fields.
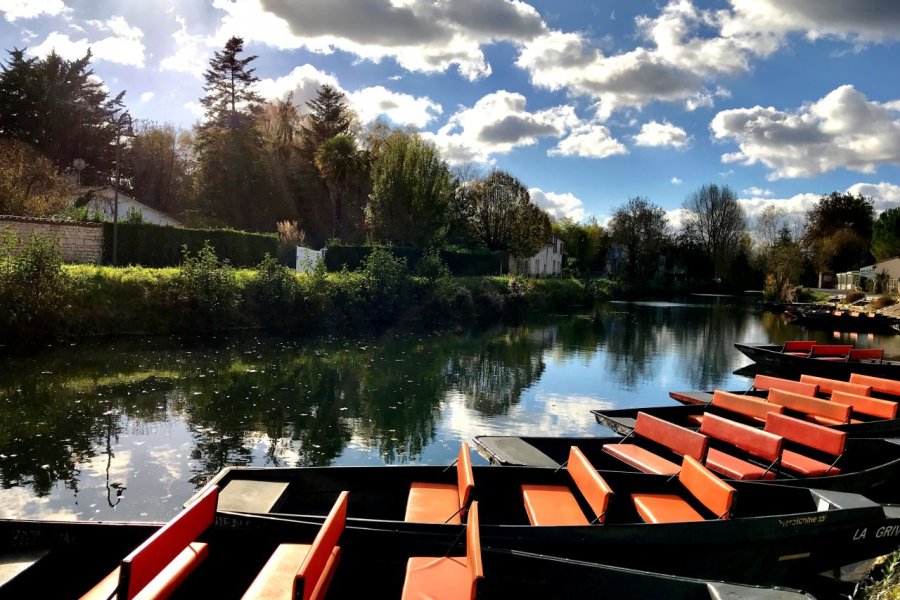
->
xmin=0 ymin=248 xmax=603 ymax=350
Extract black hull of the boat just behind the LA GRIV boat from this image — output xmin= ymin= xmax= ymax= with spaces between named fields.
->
xmin=473 ymin=432 xmax=900 ymax=503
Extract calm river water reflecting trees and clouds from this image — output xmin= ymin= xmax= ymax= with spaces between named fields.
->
xmin=0 ymin=297 xmax=900 ymax=520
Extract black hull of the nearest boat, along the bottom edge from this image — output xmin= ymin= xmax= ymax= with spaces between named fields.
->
xmin=0 ymin=500 xmax=812 ymax=600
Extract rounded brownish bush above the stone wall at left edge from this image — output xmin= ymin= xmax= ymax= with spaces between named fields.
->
xmin=0 ymin=138 xmax=69 ymax=217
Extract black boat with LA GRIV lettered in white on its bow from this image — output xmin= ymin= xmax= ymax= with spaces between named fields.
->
xmin=202 ymin=459 xmax=900 ymax=587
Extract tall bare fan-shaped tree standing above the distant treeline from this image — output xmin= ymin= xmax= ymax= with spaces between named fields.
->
xmin=684 ymin=183 xmax=746 ymax=280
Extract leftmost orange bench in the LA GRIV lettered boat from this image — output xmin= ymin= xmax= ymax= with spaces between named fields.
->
xmin=404 ymin=442 xmax=475 ymax=524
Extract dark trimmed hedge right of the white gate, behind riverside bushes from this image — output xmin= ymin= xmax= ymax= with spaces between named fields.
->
xmin=325 ymin=246 xmax=502 ymax=277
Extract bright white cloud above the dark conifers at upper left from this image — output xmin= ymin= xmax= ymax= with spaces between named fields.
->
xmin=28 ymin=16 xmax=145 ymax=67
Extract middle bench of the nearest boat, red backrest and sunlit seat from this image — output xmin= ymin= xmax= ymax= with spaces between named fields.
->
xmin=242 ymin=491 xmax=348 ymax=600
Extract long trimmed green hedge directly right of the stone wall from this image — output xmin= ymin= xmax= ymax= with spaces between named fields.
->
xmin=103 ymin=223 xmax=279 ymax=267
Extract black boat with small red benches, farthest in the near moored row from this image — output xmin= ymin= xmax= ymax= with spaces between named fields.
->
xmin=734 ymin=343 xmax=900 ymax=380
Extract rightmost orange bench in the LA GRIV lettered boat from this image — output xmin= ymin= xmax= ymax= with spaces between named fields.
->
xmin=631 ymin=456 xmax=735 ymax=523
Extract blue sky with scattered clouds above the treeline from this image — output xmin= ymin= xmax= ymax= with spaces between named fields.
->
xmin=0 ymin=0 xmax=900 ymax=226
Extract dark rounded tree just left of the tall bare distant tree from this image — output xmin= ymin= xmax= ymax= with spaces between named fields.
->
xmin=609 ymin=196 xmax=669 ymax=283
